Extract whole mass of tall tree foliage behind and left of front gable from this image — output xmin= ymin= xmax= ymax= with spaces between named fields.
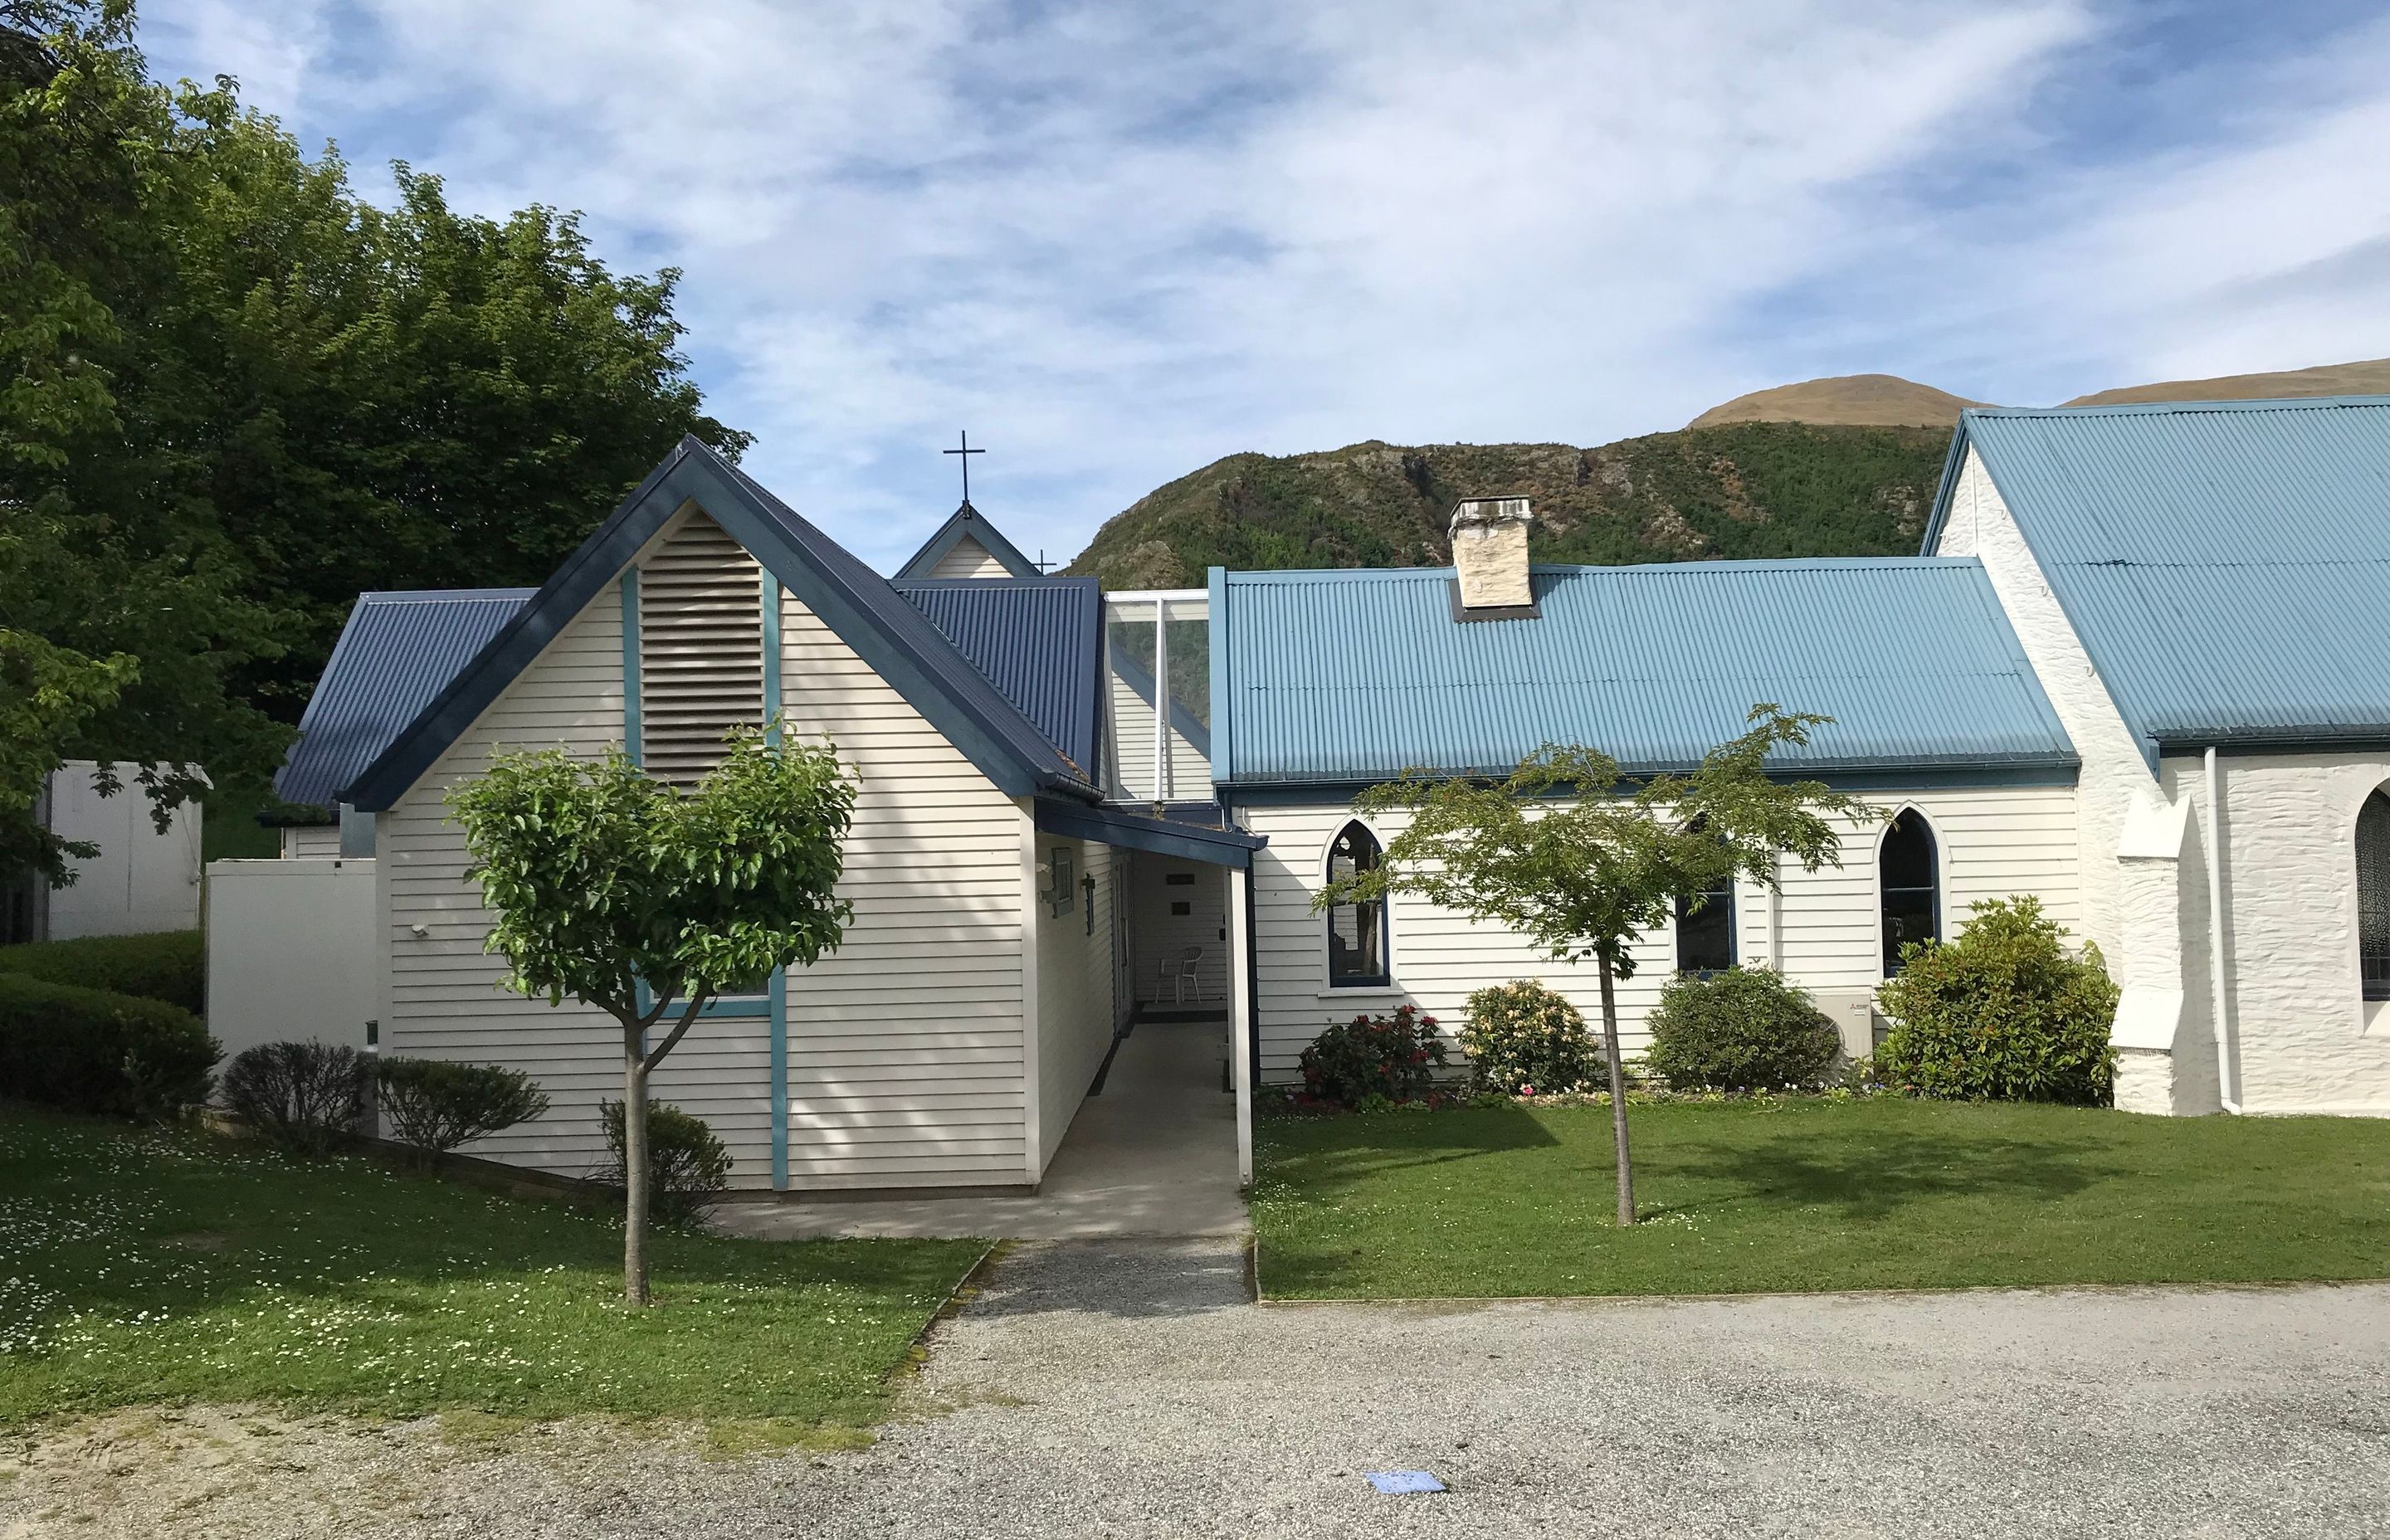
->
xmin=0 ymin=0 xmax=748 ymax=873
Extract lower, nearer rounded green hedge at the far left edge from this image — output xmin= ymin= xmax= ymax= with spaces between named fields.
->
xmin=0 ymin=973 xmax=225 ymax=1119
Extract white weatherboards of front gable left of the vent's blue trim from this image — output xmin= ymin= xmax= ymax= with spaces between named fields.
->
xmin=375 ymin=583 xmax=631 ymax=1177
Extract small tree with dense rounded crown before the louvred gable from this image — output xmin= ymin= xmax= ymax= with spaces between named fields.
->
xmin=449 ymin=729 xmax=856 ymax=1306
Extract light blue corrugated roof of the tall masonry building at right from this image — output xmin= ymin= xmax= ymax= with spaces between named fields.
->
xmin=1926 ymin=397 xmax=2390 ymax=756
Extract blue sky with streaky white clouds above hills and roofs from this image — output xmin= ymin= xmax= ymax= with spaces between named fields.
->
xmin=144 ymin=0 xmax=2390 ymax=569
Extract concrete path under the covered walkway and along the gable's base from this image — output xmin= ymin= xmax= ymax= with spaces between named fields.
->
xmin=712 ymin=1021 xmax=1247 ymax=1241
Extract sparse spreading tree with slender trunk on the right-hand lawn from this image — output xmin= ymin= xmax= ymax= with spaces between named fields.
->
xmin=1312 ymin=705 xmax=1871 ymax=1225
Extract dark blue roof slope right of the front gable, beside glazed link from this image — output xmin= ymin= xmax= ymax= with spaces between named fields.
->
xmin=894 ymin=577 xmax=1105 ymax=775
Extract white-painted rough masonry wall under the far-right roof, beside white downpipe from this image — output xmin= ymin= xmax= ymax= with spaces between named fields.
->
xmin=2158 ymin=753 xmax=2390 ymax=1117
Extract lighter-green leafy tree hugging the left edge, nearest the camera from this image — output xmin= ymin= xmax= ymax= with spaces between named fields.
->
xmin=0 ymin=0 xmax=289 ymax=880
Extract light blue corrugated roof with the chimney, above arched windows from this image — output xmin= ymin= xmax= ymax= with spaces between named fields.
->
xmin=1212 ymin=558 xmax=2075 ymax=787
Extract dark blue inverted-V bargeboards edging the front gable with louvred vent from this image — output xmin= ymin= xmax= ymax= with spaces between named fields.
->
xmin=344 ymin=437 xmax=1100 ymax=811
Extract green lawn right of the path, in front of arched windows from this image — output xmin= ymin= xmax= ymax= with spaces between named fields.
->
xmin=1252 ymin=1098 xmax=2390 ymax=1299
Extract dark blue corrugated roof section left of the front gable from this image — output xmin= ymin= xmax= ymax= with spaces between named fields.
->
xmin=275 ymin=588 xmax=538 ymax=811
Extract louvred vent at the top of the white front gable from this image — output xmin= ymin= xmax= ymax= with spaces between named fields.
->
xmin=638 ymin=514 xmax=765 ymax=784
